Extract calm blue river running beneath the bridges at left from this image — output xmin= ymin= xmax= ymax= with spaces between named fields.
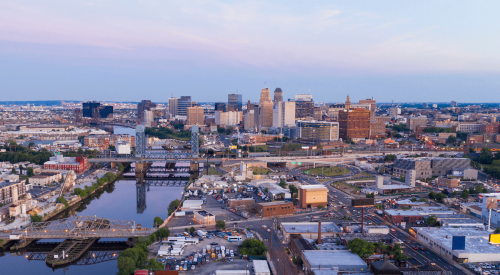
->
xmin=0 ymin=127 xmax=184 ymax=275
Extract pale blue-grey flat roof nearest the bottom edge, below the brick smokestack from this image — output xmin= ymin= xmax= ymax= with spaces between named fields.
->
xmin=303 ymin=250 xmax=366 ymax=268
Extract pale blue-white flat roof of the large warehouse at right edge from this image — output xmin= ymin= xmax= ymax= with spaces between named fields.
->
xmin=415 ymin=227 xmax=500 ymax=257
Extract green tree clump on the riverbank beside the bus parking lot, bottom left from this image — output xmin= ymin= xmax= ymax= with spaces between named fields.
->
xmin=117 ymin=228 xmax=170 ymax=275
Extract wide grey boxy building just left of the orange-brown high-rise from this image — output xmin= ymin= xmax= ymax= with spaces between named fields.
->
xmin=296 ymin=120 xmax=339 ymax=142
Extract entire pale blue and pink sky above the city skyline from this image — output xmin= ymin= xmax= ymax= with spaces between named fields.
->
xmin=0 ymin=0 xmax=500 ymax=102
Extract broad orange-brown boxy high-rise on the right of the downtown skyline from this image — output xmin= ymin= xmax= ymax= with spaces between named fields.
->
xmin=339 ymin=108 xmax=370 ymax=140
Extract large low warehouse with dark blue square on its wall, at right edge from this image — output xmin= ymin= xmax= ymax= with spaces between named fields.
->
xmin=414 ymin=227 xmax=500 ymax=263
